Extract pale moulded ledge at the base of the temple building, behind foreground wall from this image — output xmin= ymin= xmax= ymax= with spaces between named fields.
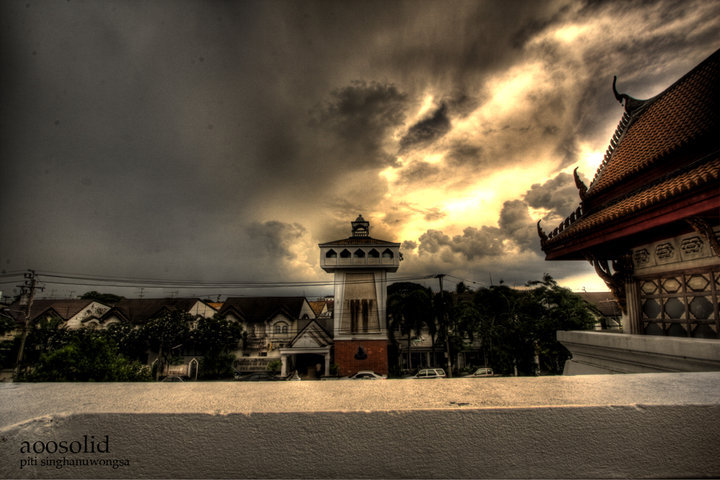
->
xmin=557 ymin=331 xmax=720 ymax=375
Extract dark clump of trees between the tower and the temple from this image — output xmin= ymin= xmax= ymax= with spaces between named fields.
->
xmin=387 ymin=275 xmax=601 ymax=375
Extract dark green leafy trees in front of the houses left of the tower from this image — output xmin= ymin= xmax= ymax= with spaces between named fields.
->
xmin=0 ymin=311 xmax=244 ymax=382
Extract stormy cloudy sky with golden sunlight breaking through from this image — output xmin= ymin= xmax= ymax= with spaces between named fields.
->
xmin=0 ymin=0 xmax=720 ymax=296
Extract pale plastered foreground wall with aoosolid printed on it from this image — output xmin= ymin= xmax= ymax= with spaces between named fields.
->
xmin=0 ymin=373 xmax=720 ymax=478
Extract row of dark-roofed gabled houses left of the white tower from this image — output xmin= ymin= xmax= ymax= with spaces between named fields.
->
xmin=0 ymin=297 xmax=333 ymax=374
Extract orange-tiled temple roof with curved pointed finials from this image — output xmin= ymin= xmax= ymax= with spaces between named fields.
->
xmin=538 ymin=50 xmax=720 ymax=259
